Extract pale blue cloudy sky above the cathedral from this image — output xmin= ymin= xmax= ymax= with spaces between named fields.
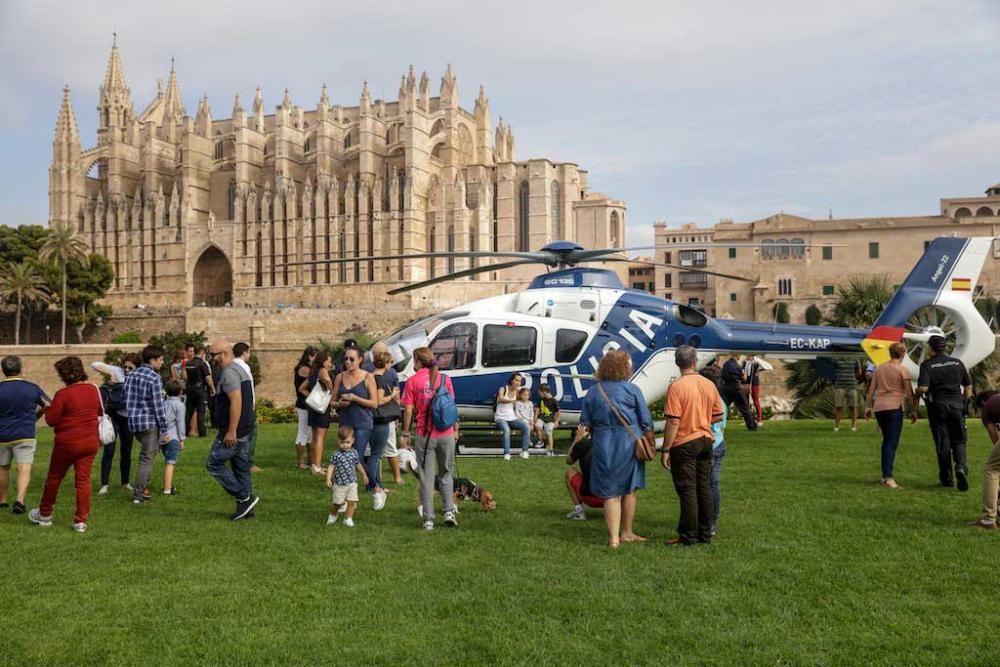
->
xmin=0 ymin=0 xmax=1000 ymax=245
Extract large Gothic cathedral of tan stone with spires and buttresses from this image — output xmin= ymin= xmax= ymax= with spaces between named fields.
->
xmin=49 ymin=44 xmax=625 ymax=307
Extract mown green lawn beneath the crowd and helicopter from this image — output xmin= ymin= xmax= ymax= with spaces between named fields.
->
xmin=0 ymin=421 xmax=1000 ymax=665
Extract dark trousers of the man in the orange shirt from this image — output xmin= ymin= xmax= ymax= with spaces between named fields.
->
xmin=670 ymin=438 xmax=714 ymax=544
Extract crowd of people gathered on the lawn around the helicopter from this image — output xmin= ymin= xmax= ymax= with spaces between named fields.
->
xmin=0 ymin=336 xmax=1000 ymax=549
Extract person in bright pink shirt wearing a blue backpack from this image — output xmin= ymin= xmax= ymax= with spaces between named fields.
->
xmin=402 ymin=347 xmax=458 ymax=530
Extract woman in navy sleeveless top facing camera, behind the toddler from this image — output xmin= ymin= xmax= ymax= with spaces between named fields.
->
xmin=333 ymin=347 xmax=380 ymax=509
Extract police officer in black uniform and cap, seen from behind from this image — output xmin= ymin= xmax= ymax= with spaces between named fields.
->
xmin=917 ymin=336 xmax=972 ymax=491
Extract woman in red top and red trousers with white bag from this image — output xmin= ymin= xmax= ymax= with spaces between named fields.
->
xmin=28 ymin=357 xmax=101 ymax=533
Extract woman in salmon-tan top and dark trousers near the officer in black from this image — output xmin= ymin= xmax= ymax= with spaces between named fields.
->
xmin=865 ymin=343 xmax=917 ymax=489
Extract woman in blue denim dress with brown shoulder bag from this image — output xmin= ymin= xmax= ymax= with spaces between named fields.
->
xmin=580 ymin=350 xmax=653 ymax=549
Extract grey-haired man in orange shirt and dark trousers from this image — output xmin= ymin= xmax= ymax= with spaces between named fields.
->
xmin=661 ymin=345 xmax=722 ymax=546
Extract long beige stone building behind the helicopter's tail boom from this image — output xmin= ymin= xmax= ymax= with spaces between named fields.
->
xmin=654 ymin=184 xmax=1000 ymax=322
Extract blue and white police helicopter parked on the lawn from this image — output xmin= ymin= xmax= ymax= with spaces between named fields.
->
xmin=292 ymin=237 xmax=995 ymax=424
